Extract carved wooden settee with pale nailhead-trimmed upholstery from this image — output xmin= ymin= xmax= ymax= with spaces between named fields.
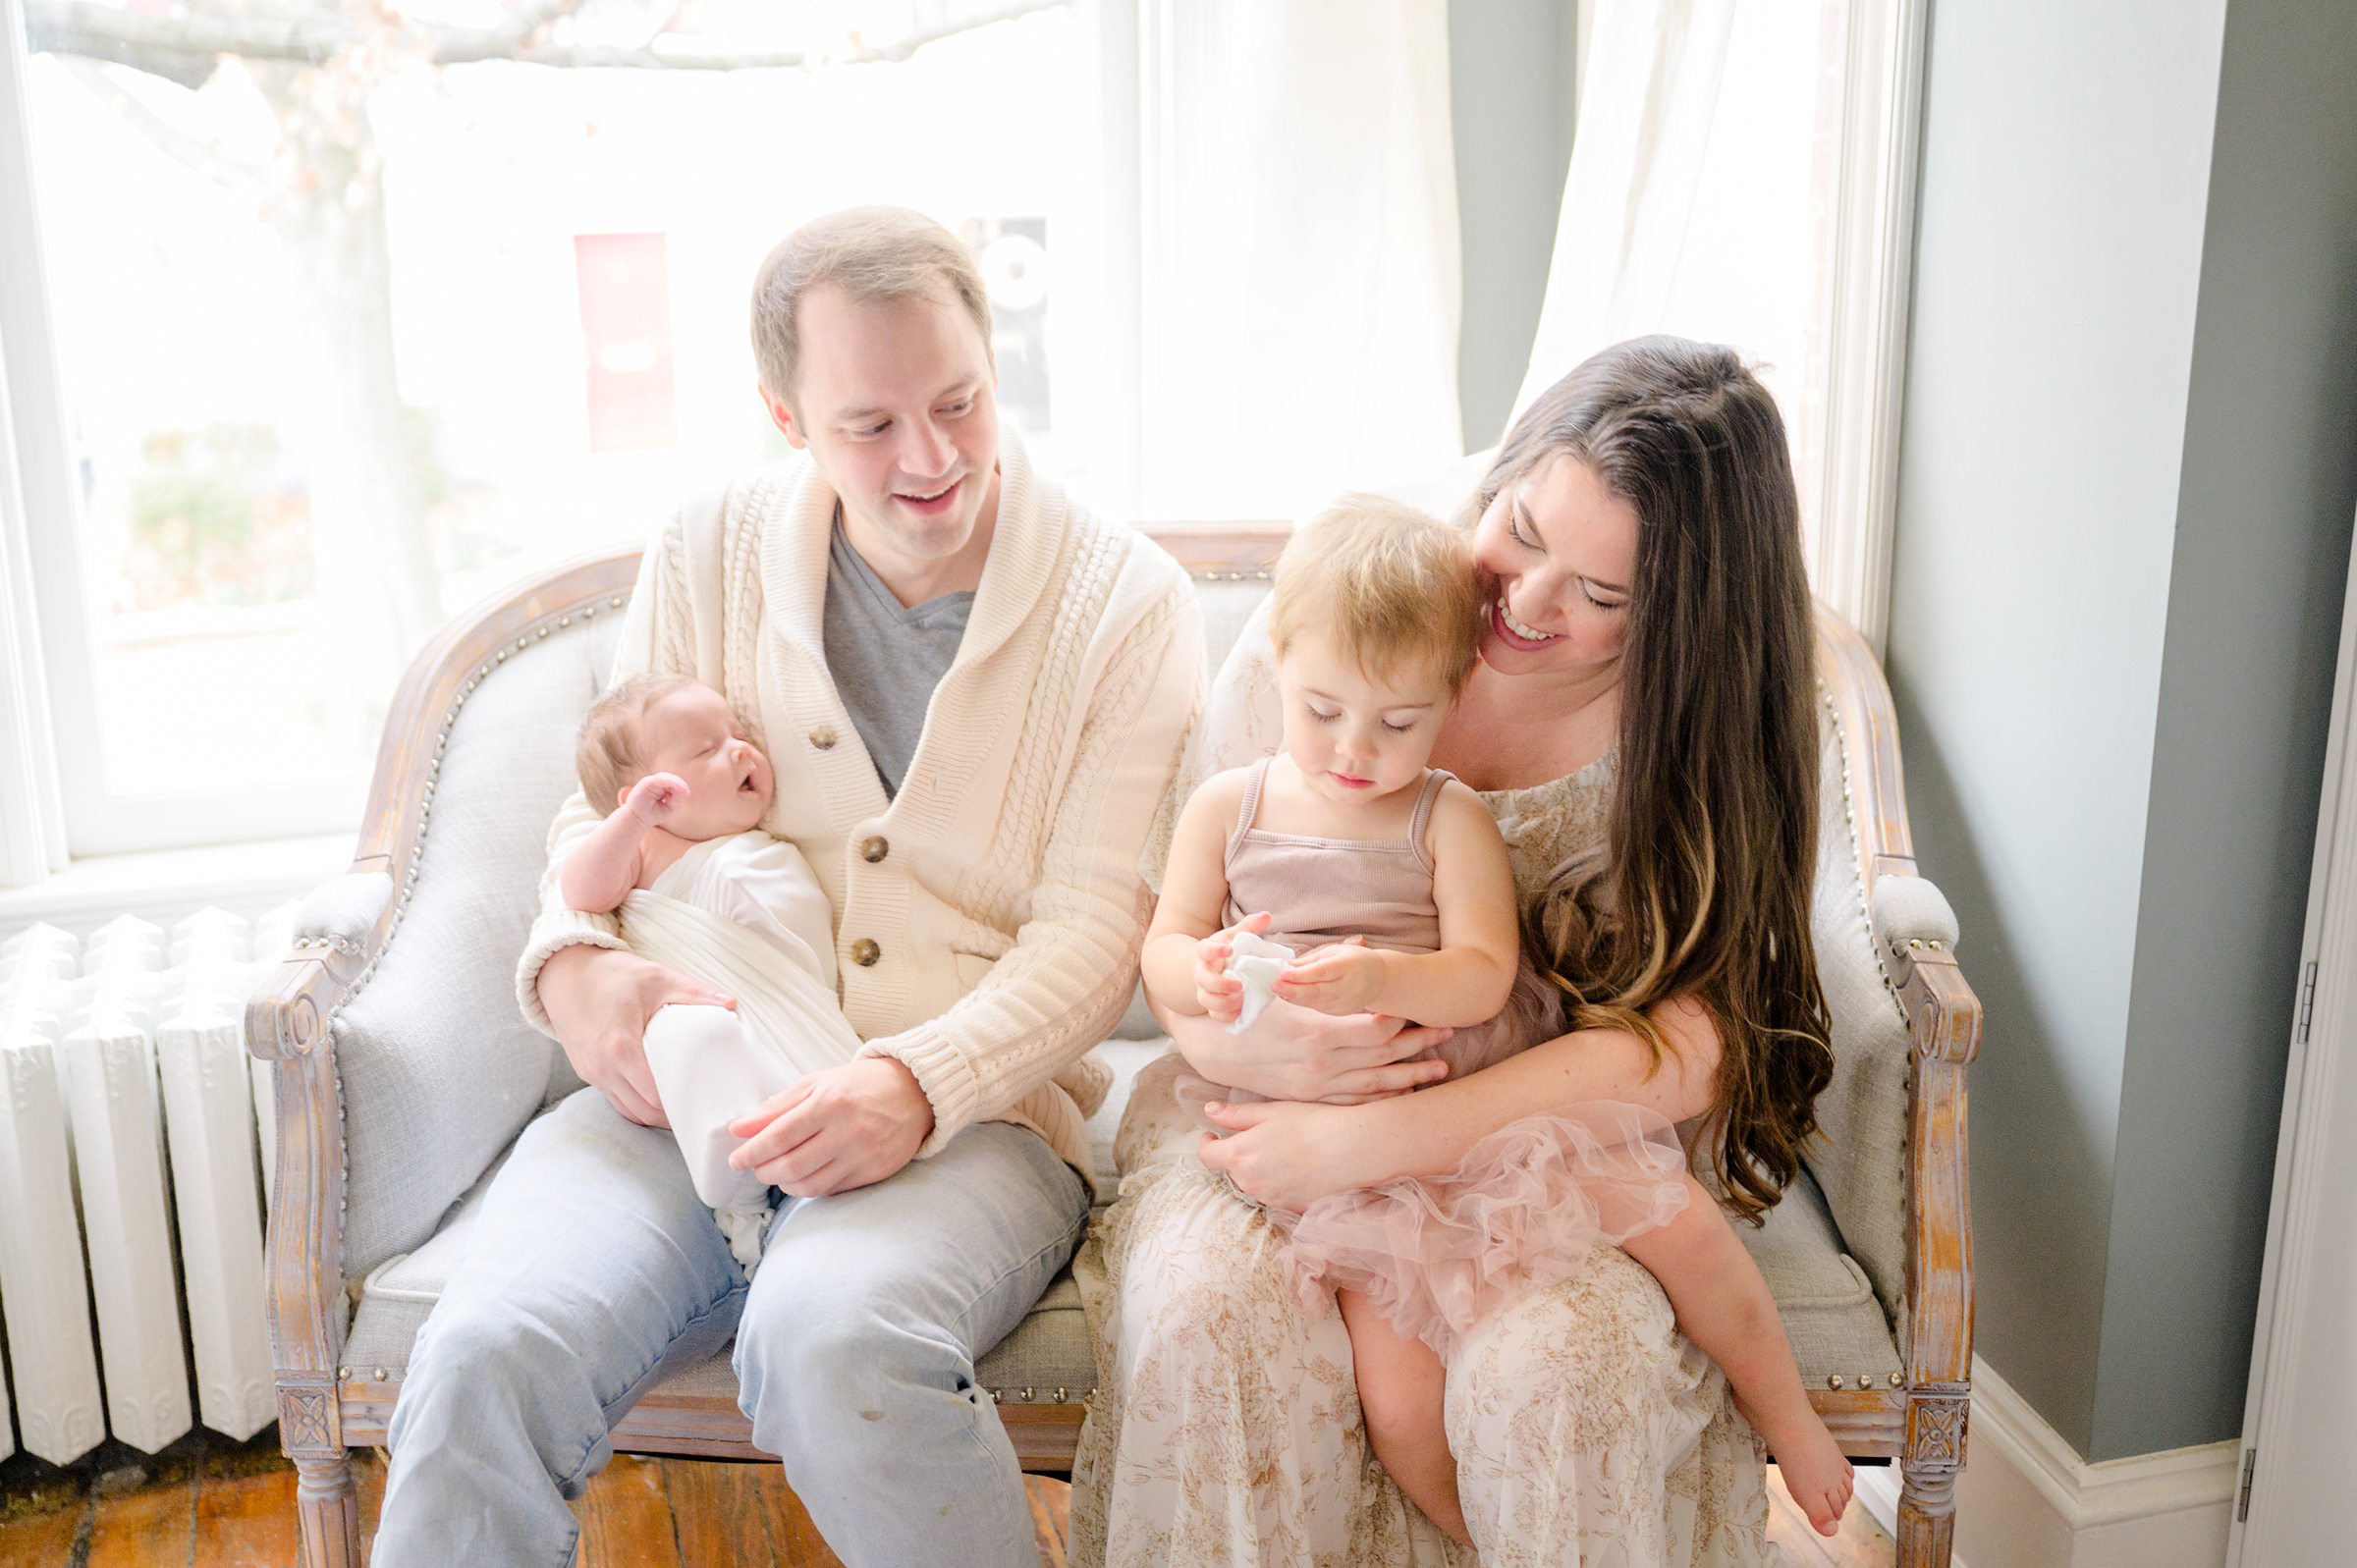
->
xmin=247 ymin=526 xmax=1980 ymax=1568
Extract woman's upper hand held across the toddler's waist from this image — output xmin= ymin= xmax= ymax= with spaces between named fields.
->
xmin=1162 ymin=1002 xmax=1454 ymax=1104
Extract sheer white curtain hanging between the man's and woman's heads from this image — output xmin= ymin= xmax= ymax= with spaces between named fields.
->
xmin=1136 ymin=0 xmax=1463 ymax=518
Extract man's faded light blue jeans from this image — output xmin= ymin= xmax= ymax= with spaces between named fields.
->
xmin=375 ymin=1089 xmax=1089 ymax=1568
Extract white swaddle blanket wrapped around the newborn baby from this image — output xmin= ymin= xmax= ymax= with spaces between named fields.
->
xmin=620 ymin=833 xmax=860 ymax=1269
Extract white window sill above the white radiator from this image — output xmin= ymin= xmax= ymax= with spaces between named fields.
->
xmin=0 ymin=833 xmax=354 ymax=934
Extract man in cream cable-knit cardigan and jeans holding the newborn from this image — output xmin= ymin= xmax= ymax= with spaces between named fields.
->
xmin=375 ymin=207 xmax=1202 ymax=1568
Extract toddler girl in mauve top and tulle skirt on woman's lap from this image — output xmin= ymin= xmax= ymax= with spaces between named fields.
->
xmin=1143 ymin=498 xmax=1850 ymax=1540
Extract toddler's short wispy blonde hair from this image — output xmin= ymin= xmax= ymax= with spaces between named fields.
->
xmin=1268 ymin=495 xmax=1483 ymax=693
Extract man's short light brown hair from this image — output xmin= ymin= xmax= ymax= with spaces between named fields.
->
xmin=752 ymin=207 xmax=990 ymax=404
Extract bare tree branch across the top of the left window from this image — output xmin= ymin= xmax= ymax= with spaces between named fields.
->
xmin=26 ymin=0 xmax=1066 ymax=87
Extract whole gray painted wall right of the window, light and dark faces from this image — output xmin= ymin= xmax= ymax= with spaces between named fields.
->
xmin=1888 ymin=0 xmax=2357 ymax=1460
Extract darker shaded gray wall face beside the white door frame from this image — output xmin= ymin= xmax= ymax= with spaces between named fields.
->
xmin=2093 ymin=0 xmax=2357 ymax=1457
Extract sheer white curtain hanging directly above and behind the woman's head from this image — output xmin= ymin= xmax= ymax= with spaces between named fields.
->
xmin=1515 ymin=0 xmax=1886 ymax=634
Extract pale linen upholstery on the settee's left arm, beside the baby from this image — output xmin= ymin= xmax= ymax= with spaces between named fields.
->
xmin=335 ymin=616 xmax=620 ymax=1275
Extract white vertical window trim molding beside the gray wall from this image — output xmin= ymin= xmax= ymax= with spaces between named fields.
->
xmin=1810 ymin=0 xmax=1931 ymax=658
